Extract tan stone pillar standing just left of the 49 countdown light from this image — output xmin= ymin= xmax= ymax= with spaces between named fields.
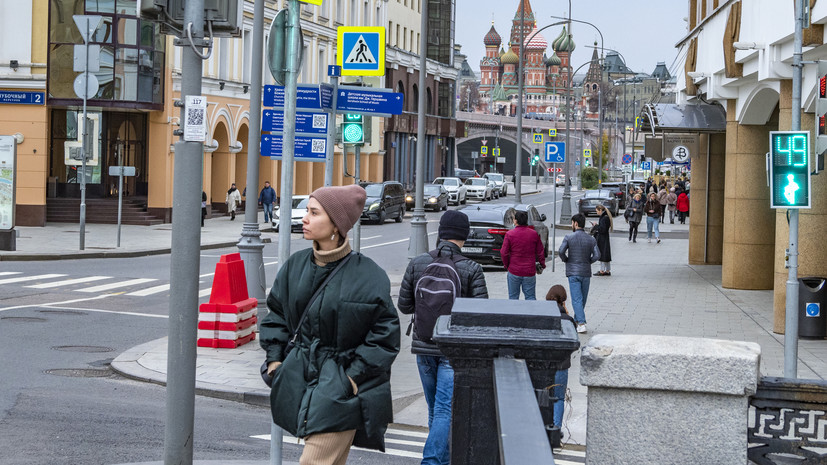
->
xmin=724 ymin=100 xmax=778 ymax=289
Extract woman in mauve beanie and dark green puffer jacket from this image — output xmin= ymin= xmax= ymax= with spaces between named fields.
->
xmin=260 ymin=184 xmax=400 ymax=465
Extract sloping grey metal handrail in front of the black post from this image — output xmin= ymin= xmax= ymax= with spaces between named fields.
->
xmin=494 ymin=357 xmax=554 ymax=465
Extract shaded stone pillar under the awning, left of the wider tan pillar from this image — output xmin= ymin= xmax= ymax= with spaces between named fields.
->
xmin=689 ymin=134 xmax=726 ymax=265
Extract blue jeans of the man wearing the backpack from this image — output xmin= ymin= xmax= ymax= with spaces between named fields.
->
xmin=416 ymin=355 xmax=454 ymax=465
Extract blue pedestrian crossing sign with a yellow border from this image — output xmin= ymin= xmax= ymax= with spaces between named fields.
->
xmin=336 ymin=26 xmax=385 ymax=76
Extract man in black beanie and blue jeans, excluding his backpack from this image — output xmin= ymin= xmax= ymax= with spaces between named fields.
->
xmin=397 ymin=210 xmax=488 ymax=465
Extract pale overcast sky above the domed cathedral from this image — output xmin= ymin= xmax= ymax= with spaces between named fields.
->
xmin=456 ymin=0 xmax=688 ymax=75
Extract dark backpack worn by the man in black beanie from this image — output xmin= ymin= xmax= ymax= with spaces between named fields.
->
xmin=411 ymin=250 xmax=466 ymax=344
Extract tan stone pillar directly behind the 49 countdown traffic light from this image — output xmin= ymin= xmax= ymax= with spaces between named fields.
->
xmin=767 ymin=99 xmax=827 ymax=333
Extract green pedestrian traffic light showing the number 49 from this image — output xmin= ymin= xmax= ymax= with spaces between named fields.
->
xmin=769 ymin=131 xmax=810 ymax=208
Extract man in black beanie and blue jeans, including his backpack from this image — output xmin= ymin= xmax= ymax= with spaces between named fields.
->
xmin=397 ymin=210 xmax=488 ymax=465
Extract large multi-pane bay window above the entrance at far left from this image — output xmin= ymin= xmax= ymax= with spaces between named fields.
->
xmin=48 ymin=0 xmax=166 ymax=109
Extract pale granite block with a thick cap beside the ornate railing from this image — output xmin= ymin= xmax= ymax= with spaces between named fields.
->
xmin=580 ymin=334 xmax=761 ymax=465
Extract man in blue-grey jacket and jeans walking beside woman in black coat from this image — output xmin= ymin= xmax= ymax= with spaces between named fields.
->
xmin=557 ymin=213 xmax=600 ymax=333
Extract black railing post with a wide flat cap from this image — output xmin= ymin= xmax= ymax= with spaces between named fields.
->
xmin=433 ymin=299 xmax=580 ymax=465
